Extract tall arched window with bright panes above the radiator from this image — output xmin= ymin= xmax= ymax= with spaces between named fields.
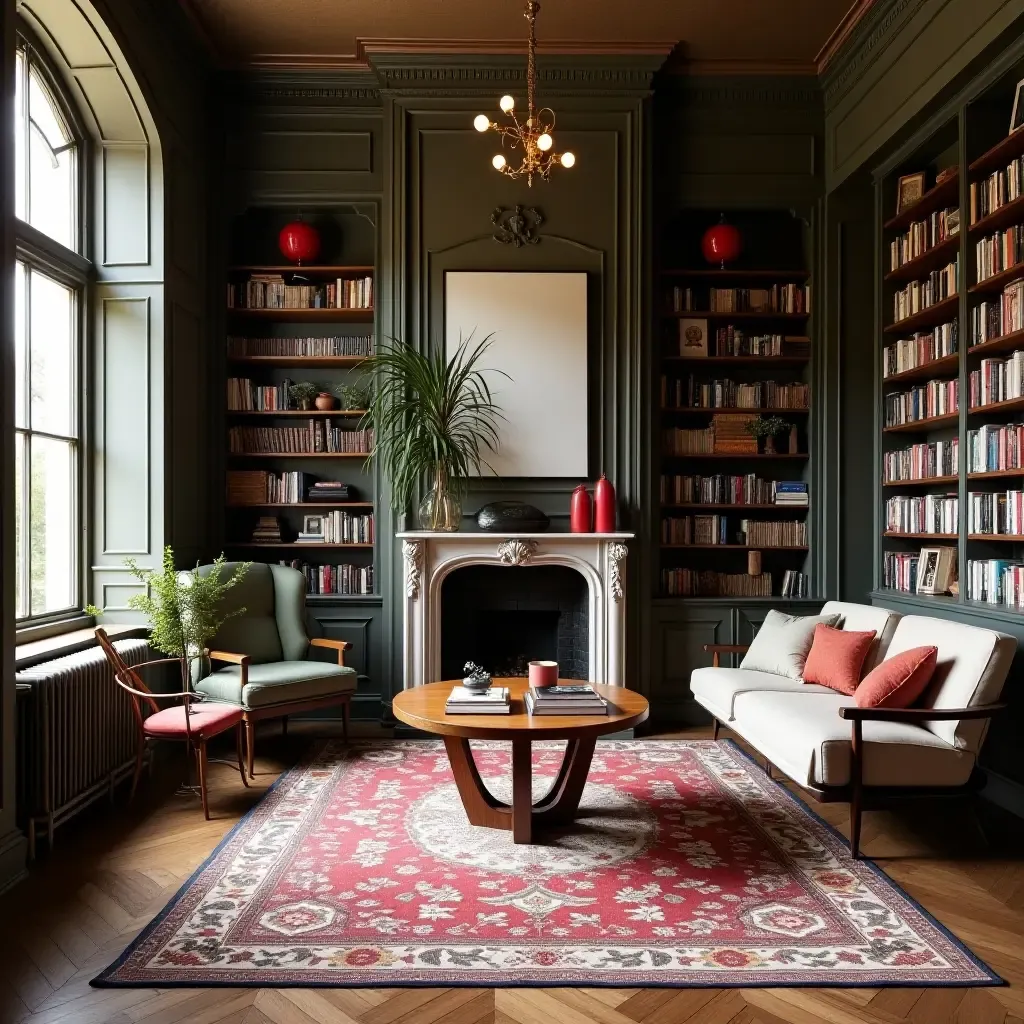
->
xmin=14 ymin=37 xmax=90 ymax=624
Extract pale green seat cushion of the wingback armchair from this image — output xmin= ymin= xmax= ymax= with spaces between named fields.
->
xmin=196 ymin=662 xmax=356 ymax=710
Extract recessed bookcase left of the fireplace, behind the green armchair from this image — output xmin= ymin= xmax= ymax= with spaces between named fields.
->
xmin=224 ymin=208 xmax=379 ymax=601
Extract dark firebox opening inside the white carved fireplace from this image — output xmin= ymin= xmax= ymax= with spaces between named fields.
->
xmin=441 ymin=565 xmax=590 ymax=679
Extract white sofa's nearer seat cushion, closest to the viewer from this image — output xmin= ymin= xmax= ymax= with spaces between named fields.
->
xmin=729 ymin=690 xmax=975 ymax=786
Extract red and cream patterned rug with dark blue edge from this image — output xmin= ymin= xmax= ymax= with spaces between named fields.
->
xmin=93 ymin=740 xmax=999 ymax=988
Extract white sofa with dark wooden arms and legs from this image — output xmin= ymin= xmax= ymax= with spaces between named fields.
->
xmin=690 ymin=601 xmax=1017 ymax=856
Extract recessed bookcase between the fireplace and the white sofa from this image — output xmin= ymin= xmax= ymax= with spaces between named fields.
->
xmin=655 ymin=210 xmax=815 ymax=602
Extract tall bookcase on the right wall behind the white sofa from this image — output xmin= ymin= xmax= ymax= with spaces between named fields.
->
xmin=877 ymin=69 xmax=1024 ymax=613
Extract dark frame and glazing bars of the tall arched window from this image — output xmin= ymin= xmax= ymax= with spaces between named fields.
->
xmin=14 ymin=29 xmax=94 ymax=630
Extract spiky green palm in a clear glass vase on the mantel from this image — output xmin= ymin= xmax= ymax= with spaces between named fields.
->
xmin=368 ymin=335 xmax=508 ymax=531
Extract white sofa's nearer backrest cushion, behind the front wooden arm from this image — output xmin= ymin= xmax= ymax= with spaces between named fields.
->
xmin=889 ymin=615 xmax=1017 ymax=754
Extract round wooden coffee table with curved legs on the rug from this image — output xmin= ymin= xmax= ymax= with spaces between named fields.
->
xmin=391 ymin=679 xmax=649 ymax=843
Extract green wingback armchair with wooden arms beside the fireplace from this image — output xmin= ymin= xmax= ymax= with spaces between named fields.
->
xmin=194 ymin=562 xmax=356 ymax=778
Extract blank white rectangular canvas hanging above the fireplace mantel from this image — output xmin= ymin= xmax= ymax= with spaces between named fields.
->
xmin=444 ymin=270 xmax=589 ymax=477
